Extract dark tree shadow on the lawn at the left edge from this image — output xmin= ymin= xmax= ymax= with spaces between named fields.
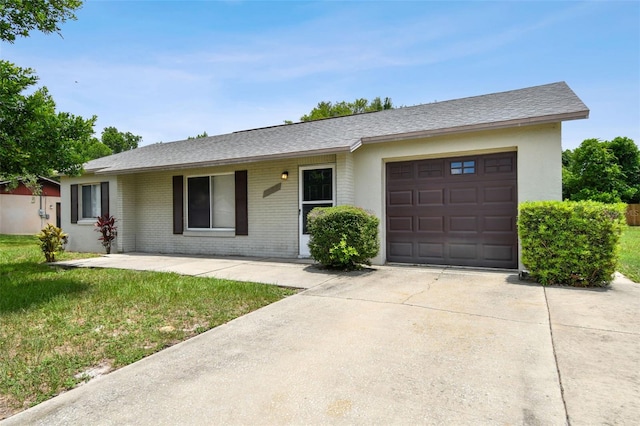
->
xmin=0 ymin=262 xmax=89 ymax=315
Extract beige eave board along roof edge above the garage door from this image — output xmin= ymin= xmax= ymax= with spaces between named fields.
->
xmin=358 ymin=109 xmax=589 ymax=146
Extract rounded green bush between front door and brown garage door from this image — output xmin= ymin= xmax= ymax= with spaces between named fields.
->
xmin=307 ymin=206 xmax=380 ymax=269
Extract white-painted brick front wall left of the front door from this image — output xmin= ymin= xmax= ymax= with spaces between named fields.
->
xmin=63 ymin=155 xmax=345 ymax=258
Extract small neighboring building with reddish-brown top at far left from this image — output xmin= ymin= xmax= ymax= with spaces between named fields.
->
xmin=0 ymin=177 xmax=60 ymax=235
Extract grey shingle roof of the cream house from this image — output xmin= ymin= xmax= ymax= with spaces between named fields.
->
xmin=85 ymin=82 xmax=589 ymax=174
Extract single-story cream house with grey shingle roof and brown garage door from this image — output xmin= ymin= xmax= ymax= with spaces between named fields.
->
xmin=62 ymin=82 xmax=589 ymax=268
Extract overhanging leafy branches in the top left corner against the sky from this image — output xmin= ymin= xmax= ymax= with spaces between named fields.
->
xmin=0 ymin=0 xmax=82 ymax=43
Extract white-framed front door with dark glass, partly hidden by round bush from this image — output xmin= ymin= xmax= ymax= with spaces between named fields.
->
xmin=299 ymin=165 xmax=336 ymax=257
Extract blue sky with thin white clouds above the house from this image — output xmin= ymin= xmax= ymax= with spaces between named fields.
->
xmin=0 ymin=0 xmax=640 ymax=149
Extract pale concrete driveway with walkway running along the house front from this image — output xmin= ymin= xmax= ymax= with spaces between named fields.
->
xmin=2 ymin=255 xmax=640 ymax=426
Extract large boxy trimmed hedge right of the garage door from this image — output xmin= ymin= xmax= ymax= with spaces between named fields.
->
xmin=518 ymin=201 xmax=626 ymax=287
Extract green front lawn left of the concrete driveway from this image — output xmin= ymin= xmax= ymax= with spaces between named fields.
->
xmin=0 ymin=235 xmax=294 ymax=419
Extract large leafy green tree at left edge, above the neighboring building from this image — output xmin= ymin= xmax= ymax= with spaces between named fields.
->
xmin=0 ymin=60 xmax=96 ymax=181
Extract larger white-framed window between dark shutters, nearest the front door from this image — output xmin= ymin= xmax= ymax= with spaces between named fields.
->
xmin=187 ymin=174 xmax=236 ymax=229
